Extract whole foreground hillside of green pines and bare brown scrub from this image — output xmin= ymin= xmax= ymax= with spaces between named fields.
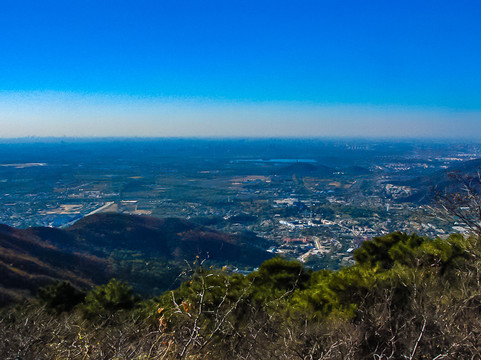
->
xmin=0 ymin=233 xmax=481 ymax=359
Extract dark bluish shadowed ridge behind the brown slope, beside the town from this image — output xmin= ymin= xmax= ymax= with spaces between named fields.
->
xmin=66 ymin=213 xmax=270 ymax=266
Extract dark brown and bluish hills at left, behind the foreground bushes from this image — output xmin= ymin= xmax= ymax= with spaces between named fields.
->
xmin=0 ymin=213 xmax=271 ymax=304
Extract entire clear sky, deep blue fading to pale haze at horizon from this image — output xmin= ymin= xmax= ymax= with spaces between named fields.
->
xmin=0 ymin=0 xmax=481 ymax=138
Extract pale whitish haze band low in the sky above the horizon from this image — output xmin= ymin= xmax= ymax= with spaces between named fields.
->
xmin=0 ymin=92 xmax=481 ymax=140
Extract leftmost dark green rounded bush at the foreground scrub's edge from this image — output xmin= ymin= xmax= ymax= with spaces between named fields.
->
xmin=37 ymin=281 xmax=85 ymax=313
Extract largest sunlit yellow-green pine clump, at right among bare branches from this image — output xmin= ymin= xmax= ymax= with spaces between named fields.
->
xmin=291 ymin=232 xmax=467 ymax=319
